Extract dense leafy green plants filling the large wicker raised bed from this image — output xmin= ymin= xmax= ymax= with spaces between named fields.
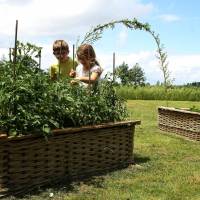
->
xmin=0 ymin=43 xmax=127 ymax=136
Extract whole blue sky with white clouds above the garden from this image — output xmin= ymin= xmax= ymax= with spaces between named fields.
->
xmin=0 ymin=0 xmax=200 ymax=84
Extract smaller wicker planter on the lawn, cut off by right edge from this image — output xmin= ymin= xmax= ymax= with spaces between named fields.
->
xmin=158 ymin=107 xmax=200 ymax=141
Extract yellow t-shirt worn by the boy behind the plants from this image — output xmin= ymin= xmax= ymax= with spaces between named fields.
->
xmin=50 ymin=57 xmax=78 ymax=80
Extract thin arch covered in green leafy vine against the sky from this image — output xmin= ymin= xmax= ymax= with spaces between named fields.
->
xmin=80 ymin=18 xmax=173 ymax=90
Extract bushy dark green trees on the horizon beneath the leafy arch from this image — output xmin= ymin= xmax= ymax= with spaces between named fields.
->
xmin=115 ymin=62 xmax=146 ymax=86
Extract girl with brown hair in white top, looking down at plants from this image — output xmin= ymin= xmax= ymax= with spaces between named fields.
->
xmin=71 ymin=44 xmax=103 ymax=86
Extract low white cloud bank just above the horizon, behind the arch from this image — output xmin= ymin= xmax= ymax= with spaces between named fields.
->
xmin=98 ymin=51 xmax=200 ymax=84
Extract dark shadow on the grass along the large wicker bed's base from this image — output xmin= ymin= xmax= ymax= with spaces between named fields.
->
xmin=5 ymin=154 xmax=150 ymax=200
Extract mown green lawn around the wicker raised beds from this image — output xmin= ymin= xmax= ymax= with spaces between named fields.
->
xmin=7 ymin=100 xmax=200 ymax=200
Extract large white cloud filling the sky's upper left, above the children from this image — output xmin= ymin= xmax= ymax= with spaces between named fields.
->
xmin=0 ymin=0 xmax=153 ymax=47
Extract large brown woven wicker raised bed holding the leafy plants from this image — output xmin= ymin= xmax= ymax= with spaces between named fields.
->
xmin=0 ymin=121 xmax=140 ymax=196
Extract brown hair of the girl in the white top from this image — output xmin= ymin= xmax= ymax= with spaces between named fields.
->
xmin=76 ymin=44 xmax=99 ymax=66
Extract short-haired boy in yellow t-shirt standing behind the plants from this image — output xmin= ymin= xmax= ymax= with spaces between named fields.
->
xmin=50 ymin=40 xmax=78 ymax=80
